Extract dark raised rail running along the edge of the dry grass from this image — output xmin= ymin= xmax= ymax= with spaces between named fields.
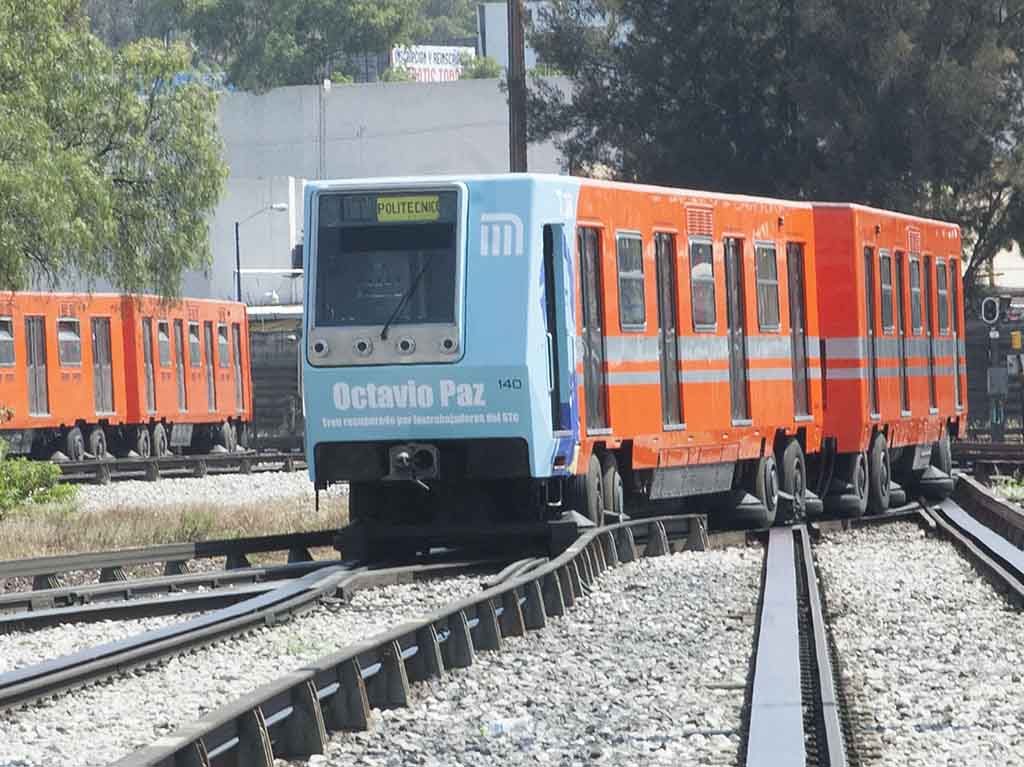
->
xmin=0 ymin=530 xmax=337 ymax=589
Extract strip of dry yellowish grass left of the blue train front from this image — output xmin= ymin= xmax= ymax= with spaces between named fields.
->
xmin=0 ymin=495 xmax=348 ymax=559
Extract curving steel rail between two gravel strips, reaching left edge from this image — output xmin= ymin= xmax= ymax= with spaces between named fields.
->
xmin=0 ymin=560 xmax=494 ymax=711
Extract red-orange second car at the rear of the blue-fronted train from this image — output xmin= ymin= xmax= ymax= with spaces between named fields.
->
xmin=814 ymin=204 xmax=967 ymax=514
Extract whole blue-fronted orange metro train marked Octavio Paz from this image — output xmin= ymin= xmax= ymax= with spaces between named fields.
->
xmin=302 ymin=174 xmax=967 ymax=526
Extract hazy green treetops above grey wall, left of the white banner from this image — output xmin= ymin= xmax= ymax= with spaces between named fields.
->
xmin=187 ymin=0 xmax=421 ymax=91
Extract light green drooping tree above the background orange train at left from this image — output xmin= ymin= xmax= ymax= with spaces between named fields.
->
xmin=0 ymin=0 xmax=226 ymax=296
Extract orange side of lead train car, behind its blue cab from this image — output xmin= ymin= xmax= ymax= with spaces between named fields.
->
xmin=575 ymin=182 xmax=822 ymax=520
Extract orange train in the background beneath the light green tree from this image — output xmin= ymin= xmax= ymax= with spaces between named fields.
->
xmin=0 ymin=293 xmax=252 ymax=460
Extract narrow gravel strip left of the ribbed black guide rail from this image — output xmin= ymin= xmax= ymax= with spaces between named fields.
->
xmin=0 ymin=578 xmax=480 ymax=767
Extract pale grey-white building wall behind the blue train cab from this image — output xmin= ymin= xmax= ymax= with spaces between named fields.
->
xmin=202 ymin=80 xmax=560 ymax=304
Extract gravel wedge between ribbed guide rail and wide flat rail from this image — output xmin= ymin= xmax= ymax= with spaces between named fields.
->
xmin=288 ymin=548 xmax=763 ymax=767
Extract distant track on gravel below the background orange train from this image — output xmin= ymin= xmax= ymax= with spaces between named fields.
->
xmin=57 ymin=452 xmax=306 ymax=484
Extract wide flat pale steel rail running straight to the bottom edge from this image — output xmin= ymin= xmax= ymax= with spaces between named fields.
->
xmin=745 ymin=525 xmax=847 ymax=767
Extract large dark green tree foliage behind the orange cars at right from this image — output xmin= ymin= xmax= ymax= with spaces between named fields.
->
xmin=530 ymin=0 xmax=1024 ymax=296
